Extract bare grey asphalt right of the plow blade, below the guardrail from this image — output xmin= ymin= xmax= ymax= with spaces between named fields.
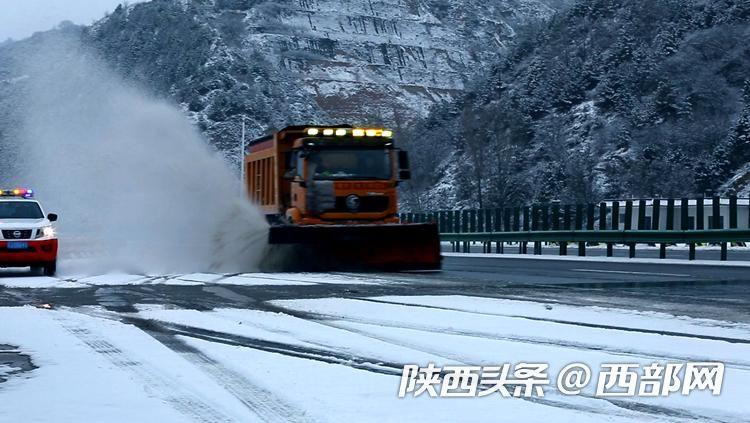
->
xmin=422 ymin=255 xmax=750 ymax=323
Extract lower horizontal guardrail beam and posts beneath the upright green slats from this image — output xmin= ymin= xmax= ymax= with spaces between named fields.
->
xmin=440 ymin=229 xmax=750 ymax=261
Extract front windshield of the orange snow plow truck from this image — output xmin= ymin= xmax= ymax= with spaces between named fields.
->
xmin=308 ymin=149 xmax=391 ymax=180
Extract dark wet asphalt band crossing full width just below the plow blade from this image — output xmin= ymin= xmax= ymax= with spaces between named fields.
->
xmin=0 ymin=255 xmax=750 ymax=323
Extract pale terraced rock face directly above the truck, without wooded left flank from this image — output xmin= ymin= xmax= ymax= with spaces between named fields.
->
xmin=229 ymin=0 xmax=554 ymax=125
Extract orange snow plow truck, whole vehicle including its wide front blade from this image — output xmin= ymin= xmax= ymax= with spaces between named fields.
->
xmin=244 ymin=126 xmax=441 ymax=270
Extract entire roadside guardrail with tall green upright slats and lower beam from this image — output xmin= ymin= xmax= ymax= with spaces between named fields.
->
xmin=400 ymin=195 xmax=750 ymax=260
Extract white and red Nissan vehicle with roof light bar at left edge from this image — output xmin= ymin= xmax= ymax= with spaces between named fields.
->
xmin=0 ymin=188 xmax=57 ymax=276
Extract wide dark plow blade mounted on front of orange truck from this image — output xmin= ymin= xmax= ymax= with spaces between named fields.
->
xmin=269 ymin=224 xmax=442 ymax=271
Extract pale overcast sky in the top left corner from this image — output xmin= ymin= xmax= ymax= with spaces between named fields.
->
xmin=0 ymin=0 xmax=151 ymax=42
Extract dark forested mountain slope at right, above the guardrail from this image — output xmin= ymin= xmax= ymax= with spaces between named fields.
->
xmin=405 ymin=0 xmax=750 ymax=209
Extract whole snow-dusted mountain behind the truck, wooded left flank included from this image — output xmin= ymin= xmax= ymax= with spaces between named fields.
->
xmin=87 ymin=0 xmax=564 ymax=147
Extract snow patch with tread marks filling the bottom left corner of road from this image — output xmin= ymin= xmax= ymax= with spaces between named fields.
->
xmin=0 ymin=307 xmax=252 ymax=422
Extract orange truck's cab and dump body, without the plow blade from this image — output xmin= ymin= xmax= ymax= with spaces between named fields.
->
xmin=246 ymin=126 xmax=410 ymax=225
